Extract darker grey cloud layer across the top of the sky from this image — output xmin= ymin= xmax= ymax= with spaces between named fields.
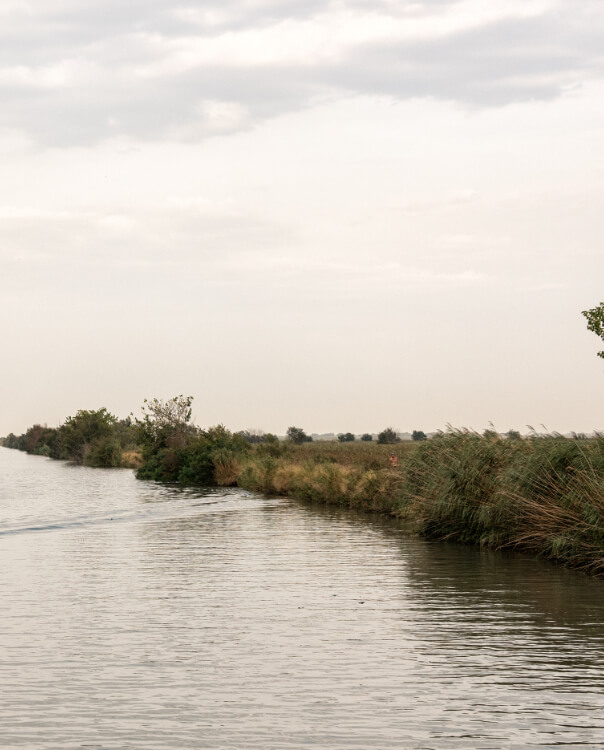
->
xmin=0 ymin=0 xmax=604 ymax=146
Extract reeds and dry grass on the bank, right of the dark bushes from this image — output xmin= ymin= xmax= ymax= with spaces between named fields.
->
xmin=232 ymin=431 xmax=604 ymax=575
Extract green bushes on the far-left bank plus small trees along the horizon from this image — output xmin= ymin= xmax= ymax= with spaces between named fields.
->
xmin=0 ymin=396 xmax=427 ymax=476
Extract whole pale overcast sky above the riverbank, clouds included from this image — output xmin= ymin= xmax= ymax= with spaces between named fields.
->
xmin=0 ymin=0 xmax=604 ymax=435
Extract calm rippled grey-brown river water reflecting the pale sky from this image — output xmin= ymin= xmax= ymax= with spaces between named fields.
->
xmin=0 ymin=449 xmax=604 ymax=750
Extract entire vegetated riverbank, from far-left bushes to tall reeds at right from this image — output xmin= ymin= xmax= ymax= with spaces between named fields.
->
xmin=3 ymin=406 xmax=604 ymax=575
